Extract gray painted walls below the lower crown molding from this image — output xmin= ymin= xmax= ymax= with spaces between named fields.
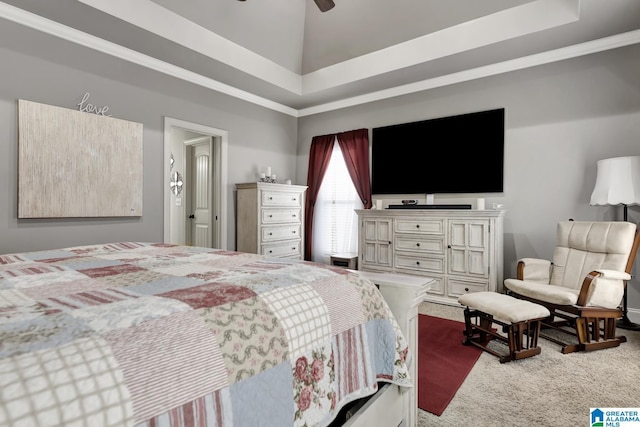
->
xmin=0 ymin=22 xmax=640 ymax=313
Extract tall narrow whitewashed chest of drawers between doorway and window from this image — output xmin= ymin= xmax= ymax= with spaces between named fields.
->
xmin=236 ymin=182 xmax=307 ymax=259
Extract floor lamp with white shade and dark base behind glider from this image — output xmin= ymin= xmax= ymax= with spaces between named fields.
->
xmin=590 ymin=156 xmax=640 ymax=331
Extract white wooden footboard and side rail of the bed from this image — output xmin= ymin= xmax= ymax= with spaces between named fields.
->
xmin=344 ymin=270 xmax=434 ymax=427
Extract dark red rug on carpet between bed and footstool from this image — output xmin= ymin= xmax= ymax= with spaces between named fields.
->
xmin=418 ymin=314 xmax=482 ymax=416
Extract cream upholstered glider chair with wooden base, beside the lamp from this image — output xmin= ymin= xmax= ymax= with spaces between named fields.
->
xmin=504 ymin=221 xmax=640 ymax=353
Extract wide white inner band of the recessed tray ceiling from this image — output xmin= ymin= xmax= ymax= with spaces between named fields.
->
xmin=78 ymin=0 xmax=580 ymax=96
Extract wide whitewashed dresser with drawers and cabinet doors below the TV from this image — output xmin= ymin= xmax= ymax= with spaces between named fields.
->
xmin=356 ymin=209 xmax=505 ymax=305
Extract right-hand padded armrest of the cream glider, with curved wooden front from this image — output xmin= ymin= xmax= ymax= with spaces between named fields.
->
xmin=576 ymin=270 xmax=631 ymax=308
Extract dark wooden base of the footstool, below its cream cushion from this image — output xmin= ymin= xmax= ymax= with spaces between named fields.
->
xmin=462 ymin=307 xmax=541 ymax=363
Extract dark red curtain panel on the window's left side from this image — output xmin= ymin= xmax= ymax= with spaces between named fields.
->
xmin=304 ymin=134 xmax=336 ymax=261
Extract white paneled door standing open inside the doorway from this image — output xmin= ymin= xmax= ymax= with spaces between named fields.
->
xmin=187 ymin=137 xmax=213 ymax=248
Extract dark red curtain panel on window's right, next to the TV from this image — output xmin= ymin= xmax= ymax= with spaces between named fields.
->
xmin=338 ymin=129 xmax=371 ymax=209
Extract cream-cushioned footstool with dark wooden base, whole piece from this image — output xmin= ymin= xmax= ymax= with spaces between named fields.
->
xmin=458 ymin=292 xmax=551 ymax=363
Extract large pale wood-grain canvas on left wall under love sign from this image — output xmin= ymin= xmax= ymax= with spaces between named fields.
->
xmin=18 ymin=99 xmax=143 ymax=218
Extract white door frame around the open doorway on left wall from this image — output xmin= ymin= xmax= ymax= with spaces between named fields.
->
xmin=162 ymin=117 xmax=229 ymax=249
